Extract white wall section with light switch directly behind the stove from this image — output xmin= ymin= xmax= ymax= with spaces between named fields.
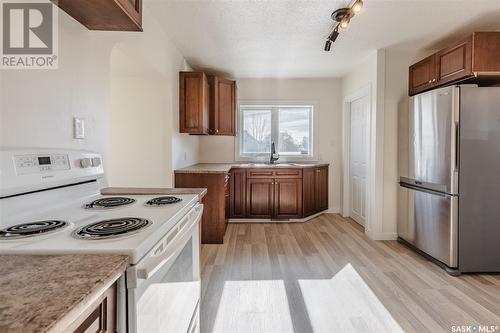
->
xmin=0 ymin=14 xmax=112 ymax=151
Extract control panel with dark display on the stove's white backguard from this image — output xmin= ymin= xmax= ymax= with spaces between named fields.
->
xmin=14 ymin=154 xmax=70 ymax=175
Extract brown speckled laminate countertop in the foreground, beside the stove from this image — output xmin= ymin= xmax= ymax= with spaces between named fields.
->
xmin=0 ymin=255 xmax=129 ymax=333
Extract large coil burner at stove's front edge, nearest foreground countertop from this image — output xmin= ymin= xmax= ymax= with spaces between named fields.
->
xmin=73 ymin=217 xmax=153 ymax=240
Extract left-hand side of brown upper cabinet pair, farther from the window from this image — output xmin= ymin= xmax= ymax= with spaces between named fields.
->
xmin=179 ymin=72 xmax=209 ymax=134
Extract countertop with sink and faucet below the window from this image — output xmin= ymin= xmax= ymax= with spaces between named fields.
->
xmin=175 ymin=162 xmax=329 ymax=173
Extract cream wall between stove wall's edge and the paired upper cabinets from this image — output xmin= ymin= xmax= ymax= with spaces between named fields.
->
xmin=108 ymin=33 xmax=198 ymax=187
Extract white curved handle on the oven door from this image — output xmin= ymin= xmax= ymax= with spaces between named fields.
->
xmin=136 ymin=204 xmax=203 ymax=280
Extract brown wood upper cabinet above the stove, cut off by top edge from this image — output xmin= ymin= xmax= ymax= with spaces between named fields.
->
xmin=52 ymin=0 xmax=142 ymax=31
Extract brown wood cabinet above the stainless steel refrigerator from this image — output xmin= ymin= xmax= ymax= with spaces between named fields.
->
xmin=409 ymin=32 xmax=500 ymax=96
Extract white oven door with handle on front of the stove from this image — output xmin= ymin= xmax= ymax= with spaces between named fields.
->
xmin=127 ymin=204 xmax=203 ymax=333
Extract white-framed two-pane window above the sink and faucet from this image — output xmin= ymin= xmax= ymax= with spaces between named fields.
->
xmin=239 ymin=105 xmax=313 ymax=158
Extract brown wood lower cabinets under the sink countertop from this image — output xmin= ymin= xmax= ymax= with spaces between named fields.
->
xmin=175 ymin=166 xmax=328 ymax=244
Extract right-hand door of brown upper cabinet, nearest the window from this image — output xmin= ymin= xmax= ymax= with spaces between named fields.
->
xmin=209 ymin=76 xmax=237 ymax=136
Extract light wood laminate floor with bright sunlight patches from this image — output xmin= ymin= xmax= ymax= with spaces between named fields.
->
xmin=201 ymin=214 xmax=500 ymax=333
